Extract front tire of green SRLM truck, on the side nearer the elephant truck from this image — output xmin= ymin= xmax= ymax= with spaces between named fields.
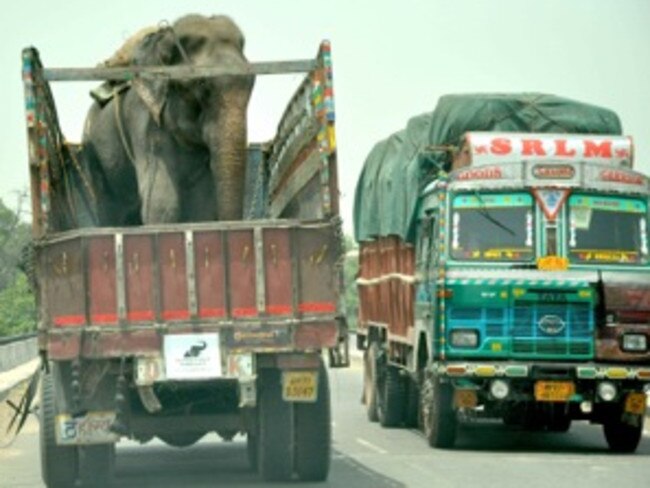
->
xmin=421 ymin=376 xmax=458 ymax=448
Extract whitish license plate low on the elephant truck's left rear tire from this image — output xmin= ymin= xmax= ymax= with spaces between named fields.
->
xmin=55 ymin=412 xmax=119 ymax=445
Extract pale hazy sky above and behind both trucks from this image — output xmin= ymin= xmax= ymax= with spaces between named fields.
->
xmin=0 ymin=0 xmax=650 ymax=232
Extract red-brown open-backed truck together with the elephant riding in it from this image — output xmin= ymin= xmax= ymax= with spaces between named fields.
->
xmin=22 ymin=15 xmax=349 ymax=488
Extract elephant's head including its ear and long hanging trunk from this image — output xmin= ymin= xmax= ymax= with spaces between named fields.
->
xmin=128 ymin=15 xmax=254 ymax=223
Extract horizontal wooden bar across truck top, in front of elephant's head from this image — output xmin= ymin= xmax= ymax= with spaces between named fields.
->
xmin=43 ymin=59 xmax=316 ymax=81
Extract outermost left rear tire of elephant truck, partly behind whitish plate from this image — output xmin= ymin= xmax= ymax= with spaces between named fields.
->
xmin=39 ymin=366 xmax=79 ymax=488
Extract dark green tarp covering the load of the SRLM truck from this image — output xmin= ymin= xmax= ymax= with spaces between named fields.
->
xmin=354 ymin=93 xmax=621 ymax=242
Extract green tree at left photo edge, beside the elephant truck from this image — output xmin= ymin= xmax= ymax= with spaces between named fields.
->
xmin=0 ymin=197 xmax=36 ymax=336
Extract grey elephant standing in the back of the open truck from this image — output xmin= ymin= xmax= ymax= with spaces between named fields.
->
xmin=82 ymin=14 xmax=255 ymax=226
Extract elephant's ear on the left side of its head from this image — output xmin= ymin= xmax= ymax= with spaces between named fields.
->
xmin=133 ymin=28 xmax=175 ymax=125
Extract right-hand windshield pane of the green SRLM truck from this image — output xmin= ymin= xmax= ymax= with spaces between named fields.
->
xmin=569 ymin=195 xmax=648 ymax=264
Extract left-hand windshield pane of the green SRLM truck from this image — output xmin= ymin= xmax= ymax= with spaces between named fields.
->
xmin=451 ymin=193 xmax=534 ymax=262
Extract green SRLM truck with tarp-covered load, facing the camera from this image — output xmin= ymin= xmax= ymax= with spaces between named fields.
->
xmin=354 ymin=93 xmax=650 ymax=452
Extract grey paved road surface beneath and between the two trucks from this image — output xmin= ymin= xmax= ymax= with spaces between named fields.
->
xmin=0 ymin=363 xmax=650 ymax=488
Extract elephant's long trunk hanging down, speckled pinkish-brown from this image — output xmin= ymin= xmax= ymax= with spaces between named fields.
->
xmin=206 ymin=88 xmax=250 ymax=220
